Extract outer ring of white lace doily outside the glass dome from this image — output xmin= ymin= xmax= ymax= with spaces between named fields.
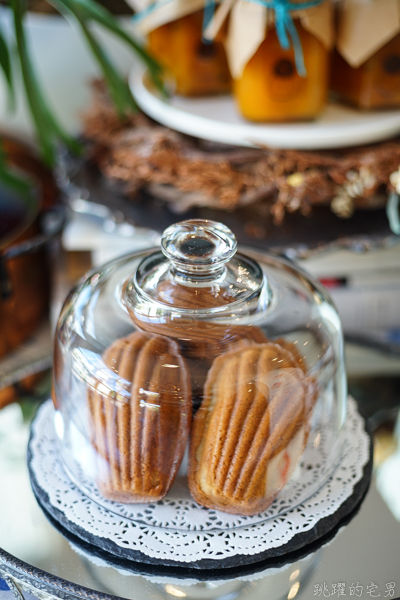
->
xmin=29 ymin=398 xmax=370 ymax=565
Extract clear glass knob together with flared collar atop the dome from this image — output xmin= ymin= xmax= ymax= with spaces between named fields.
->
xmin=122 ymin=219 xmax=269 ymax=316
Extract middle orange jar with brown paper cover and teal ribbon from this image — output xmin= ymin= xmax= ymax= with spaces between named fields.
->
xmin=227 ymin=1 xmax=333 ymax=122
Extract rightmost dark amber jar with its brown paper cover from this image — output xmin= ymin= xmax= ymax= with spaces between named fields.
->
xmin=331 ymin=0 xmax=400 ymax=109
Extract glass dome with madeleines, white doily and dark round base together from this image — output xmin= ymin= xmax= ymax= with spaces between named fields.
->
xmin=22 ymin=207 xmax=372 ymax=596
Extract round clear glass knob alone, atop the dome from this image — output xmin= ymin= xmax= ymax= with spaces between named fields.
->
xmin=161 ymin=219 xmax=237 ymax=277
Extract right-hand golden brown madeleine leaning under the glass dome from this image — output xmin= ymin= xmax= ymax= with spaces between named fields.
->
xmin=189 ymin=342 xmax=316 ymax=515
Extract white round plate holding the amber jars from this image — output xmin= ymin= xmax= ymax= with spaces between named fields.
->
xmin=129 ymin=68 xmax=400 ymax=150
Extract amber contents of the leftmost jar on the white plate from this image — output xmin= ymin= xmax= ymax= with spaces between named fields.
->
xmin=148 ymin=11 xmax=231 ymax=96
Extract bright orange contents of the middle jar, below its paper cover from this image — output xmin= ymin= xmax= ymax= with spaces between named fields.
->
xmin=234 ymin=21 xmax=329 ymax=121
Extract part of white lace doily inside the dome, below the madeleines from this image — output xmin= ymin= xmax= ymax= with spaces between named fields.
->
xmin=35 ymin=396 xmax=348 ymax=532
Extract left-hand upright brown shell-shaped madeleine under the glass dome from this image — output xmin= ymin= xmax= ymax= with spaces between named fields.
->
xmin=88 ymin=332 xmax=192 ymax=503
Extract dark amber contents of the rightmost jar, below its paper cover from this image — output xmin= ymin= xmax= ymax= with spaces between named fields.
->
xmin=331 ymin=34 xmax=400 ymax=109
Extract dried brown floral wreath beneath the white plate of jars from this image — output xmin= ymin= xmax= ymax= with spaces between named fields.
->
xmin=84 ymin=82 xmax=400 ymax=223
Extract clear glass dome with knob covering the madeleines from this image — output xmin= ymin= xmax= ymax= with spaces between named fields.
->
xmin=53 ymin=219 xmax=347 ymax=527
